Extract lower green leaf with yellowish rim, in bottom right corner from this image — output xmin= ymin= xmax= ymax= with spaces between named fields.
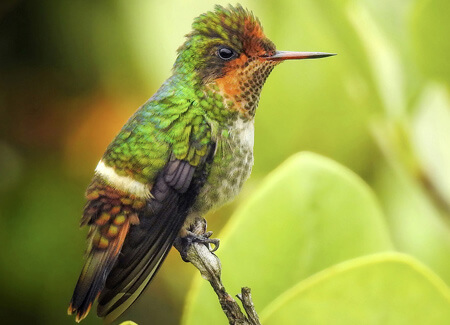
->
xmin=261 ymin=253 xmax=450 ymax=325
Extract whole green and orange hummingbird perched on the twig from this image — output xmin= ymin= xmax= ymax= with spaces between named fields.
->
xmin=68 ymin=5 xmax=334 ymax=322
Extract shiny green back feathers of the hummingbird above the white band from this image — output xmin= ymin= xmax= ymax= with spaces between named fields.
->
xmin=103 ymin=77 xmax=211 ymax=183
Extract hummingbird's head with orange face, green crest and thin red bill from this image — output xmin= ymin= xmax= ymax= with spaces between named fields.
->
xmin=174 ymin=5 xmax=332 ymax=118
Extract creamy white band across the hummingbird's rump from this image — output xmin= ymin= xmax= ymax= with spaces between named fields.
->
xmin=95 ymin=160 xmax=150 ymax=198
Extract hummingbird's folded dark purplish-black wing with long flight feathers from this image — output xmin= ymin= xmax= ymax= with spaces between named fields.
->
xmin=97 ymin=148 xmax=214 ymax=321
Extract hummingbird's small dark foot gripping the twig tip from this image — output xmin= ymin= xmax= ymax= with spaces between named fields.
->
xmin=173 ymin=216 xmax=220 ymax=262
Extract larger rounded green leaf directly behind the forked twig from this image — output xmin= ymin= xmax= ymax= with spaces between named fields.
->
xmin=183 ymin=153 xmax=392 ymax=324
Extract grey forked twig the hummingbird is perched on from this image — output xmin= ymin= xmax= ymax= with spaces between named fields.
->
xmin=175 ymin=219 xmax=261 ymax=325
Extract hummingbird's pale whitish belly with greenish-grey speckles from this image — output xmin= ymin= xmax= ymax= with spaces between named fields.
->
xmin=193 ymin=123 xmax=253 ymax=215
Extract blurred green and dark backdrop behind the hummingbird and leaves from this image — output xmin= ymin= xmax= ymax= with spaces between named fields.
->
xmin=0 ymin=0 xmax=450 ymax=324
